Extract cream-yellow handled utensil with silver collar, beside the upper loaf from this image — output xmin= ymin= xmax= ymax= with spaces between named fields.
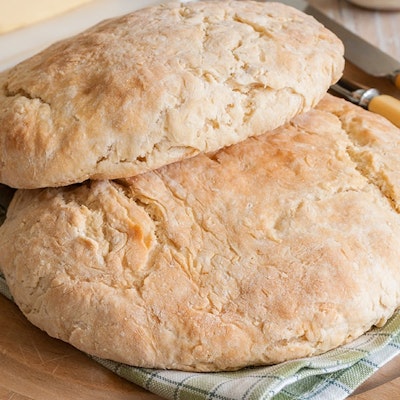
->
xmin=331 ymin=79 xmax=400 ymax=128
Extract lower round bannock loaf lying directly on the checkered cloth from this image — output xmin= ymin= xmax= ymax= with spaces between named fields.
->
xmin=0 ymin=95 xmax=400 ymax=371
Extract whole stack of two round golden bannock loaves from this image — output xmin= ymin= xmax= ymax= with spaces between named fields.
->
xmin=0 ymin=0 xmax=400 ymax=371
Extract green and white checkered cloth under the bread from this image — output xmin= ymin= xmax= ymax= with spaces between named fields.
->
xmin=0 ymin=274 xmax=400 ymax=400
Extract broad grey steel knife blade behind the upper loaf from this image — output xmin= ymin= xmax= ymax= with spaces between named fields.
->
xmin=264 ymin=0 xmax=400 ymax=88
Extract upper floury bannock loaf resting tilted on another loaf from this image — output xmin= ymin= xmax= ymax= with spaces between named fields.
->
xmin=0 ymin=1 xmax=344 ymax=188
